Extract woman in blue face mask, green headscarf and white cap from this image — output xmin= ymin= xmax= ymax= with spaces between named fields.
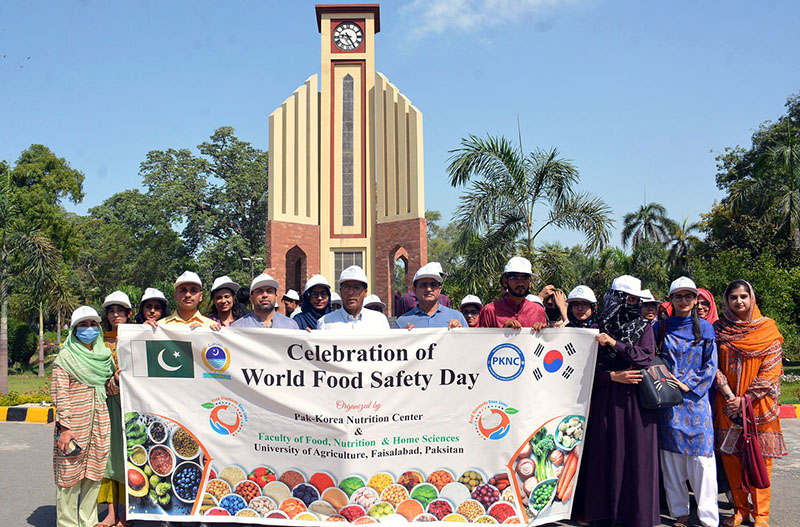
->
xmin=50 ymin=306 xmax=119 ymax=527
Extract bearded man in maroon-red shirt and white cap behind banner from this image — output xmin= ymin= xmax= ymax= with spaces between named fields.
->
xmin=478 ymin=256 xmax=547 ymax=330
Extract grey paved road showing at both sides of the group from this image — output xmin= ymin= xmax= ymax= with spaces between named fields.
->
xmin=0 ymin=419 xmax=800 ymax=527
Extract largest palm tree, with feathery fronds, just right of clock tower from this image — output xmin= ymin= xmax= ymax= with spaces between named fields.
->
xmin=447 ymin=135 xmax=613 ymax=260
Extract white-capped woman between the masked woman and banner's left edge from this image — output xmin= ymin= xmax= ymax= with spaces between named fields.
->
xmin=97 ymin=291 xmax=131 ymax=525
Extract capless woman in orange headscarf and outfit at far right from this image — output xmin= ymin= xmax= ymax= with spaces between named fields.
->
xmin=714 ymin=280 xmax=787 ymax=527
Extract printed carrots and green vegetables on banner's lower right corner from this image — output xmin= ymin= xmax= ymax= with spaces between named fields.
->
xmin=512 ymin=415 xmax=586 ymax=520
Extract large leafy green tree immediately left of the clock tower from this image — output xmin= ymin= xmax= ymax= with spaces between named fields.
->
xmin=139 ymin=126 xmax=268 ymax=279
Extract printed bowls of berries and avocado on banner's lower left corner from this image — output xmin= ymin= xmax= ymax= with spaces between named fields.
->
xmin=125 ymin=412 xmax=204 ymax=516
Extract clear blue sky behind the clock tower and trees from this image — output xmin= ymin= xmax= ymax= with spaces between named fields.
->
xmin=0 ymin=0 xmax=800 ymax=249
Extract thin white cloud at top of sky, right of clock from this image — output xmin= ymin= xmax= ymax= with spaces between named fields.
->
xmin=401 ymin=0 xmax=579 ymax=37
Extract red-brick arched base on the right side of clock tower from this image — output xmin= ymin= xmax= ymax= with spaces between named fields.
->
xmin=372 ymin=218 xmax=428 ymax=315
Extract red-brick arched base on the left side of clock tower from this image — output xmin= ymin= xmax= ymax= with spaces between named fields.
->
xmin=264 ymin=220 xmax=319 ymax=295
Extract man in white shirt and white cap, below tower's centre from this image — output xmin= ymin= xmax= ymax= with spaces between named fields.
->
xmin=317 ymin=265 xmax=389 ymax=331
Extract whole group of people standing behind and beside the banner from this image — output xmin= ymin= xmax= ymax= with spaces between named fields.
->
xmin=51 ymin=257 xmax=787 ymax=527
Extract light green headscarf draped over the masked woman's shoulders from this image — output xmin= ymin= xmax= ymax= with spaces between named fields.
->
xmin=53 ymin=328 xmax=115 ymax=402
